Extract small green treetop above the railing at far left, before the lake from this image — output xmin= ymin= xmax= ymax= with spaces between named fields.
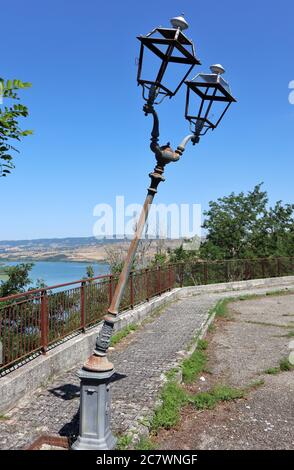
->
xmin=0 ymin=263 xmax=34 ymax=297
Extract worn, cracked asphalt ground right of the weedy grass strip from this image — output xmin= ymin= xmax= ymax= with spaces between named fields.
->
xmin=156 ymin=294 xmax=294 ymax=450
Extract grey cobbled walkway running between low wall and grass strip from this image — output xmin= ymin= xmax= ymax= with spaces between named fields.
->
xmin=0 ymin=285 xmax=292 ymax=449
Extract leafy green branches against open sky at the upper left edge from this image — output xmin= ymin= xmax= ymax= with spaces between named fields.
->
xmin=0 ymin=78 xmax=32 ymax=177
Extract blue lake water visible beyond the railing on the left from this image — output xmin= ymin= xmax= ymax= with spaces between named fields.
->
xmin=4 ymin=261 xmax=109 ymax=286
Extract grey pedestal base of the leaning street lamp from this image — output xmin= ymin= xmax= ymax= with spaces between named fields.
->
xmin=72 ymin=369 xmax=116 ymax=450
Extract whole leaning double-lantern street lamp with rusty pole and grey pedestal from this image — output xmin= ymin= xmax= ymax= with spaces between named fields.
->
xmin=73 ymin=12 xmax=236 ymax=450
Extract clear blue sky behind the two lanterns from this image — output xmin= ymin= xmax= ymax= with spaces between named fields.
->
xmin=0 ymin=0 xmax=294 ymax=240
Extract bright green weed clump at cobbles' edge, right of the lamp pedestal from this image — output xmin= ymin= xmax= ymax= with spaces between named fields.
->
xmin=151 ymin=381 xmax=188 ymax=431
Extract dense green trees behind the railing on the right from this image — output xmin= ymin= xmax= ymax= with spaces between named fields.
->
xmin=200 ymin=184 xmax=294 ymax=259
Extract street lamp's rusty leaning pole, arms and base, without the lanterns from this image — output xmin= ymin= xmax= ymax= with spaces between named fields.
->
xmin=73 ymin=81 xmax=199 ymax=450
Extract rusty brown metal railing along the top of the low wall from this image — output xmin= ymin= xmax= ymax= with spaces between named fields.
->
xmin=0 ymin=257 xmax=294 ymax=374
